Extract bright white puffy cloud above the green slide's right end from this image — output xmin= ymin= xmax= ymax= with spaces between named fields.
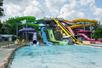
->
xmin=23 ymin=0 xmax=44 ymax=17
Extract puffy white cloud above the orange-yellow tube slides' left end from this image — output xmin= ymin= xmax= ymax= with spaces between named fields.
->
xmin=58 ymin=0 xmax=85 ymax=19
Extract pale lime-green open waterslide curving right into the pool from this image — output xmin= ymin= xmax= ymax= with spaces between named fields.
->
xmin=47 ymin=29 xmax=68 ymax=45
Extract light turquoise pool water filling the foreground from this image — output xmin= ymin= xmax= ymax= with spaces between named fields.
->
xmin=10 ymin=46 xmax=102 ymax=68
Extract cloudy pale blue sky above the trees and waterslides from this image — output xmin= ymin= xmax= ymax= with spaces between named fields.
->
xmin=2 ymin=0 xmax=102 ymax=21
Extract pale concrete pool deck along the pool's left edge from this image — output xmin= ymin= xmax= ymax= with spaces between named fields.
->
xmin=0 ymin=43 xmax=27 ymax=68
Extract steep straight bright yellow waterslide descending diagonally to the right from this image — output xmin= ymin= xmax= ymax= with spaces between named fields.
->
xmin=52 ymin=18 xmax=81 ymax=44
